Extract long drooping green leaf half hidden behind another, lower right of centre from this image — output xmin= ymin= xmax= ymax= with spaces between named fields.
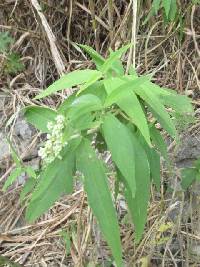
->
xmin=122 ymin=133 xmax=150 ymax=243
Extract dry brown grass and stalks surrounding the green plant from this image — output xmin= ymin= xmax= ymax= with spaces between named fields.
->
xmin=0 ymin=0 xmax=200 ymax=267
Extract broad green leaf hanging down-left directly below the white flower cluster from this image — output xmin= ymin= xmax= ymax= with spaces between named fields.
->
xmin=26 ymin=139 xmax=80 ymax=222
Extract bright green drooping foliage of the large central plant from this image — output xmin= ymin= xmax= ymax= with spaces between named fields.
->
xmin=3 ymin=45 xmax=193 ymax=267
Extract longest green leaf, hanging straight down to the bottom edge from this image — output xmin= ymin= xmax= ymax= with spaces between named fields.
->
xmin=77 ymin=139 xmax=122 ymax=267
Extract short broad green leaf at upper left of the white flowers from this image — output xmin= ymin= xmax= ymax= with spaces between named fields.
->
xmin=24 ymin=106 xmax=58 ymax=133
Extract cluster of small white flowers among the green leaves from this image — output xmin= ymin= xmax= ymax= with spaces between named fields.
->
xmin=38 ymin=115 xmax=67 ymax=165
